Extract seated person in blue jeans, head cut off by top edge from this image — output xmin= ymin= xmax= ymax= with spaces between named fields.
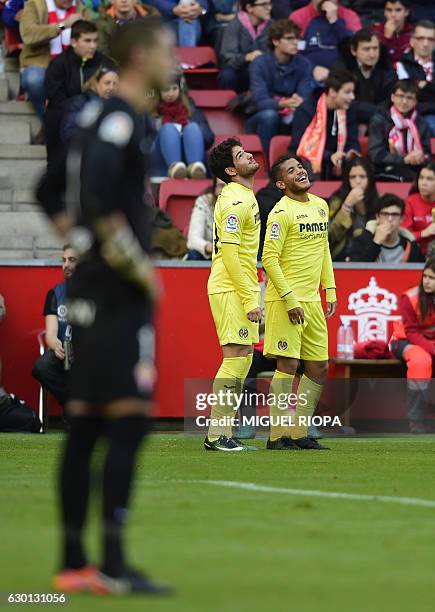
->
xmin=148 ymin=0 xmax=208 ymax=47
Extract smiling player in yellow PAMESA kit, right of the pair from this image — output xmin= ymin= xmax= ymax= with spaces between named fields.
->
xmin=263 ymin=155 xmax=337 ymax=450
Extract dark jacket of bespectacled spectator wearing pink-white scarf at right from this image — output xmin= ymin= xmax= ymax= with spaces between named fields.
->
xmin=369 ymin=110 xmax=431 ymax=170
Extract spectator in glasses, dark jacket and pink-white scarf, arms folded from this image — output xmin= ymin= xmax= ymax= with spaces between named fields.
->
xmin=369 ymin=79 xmax=431 ymax=181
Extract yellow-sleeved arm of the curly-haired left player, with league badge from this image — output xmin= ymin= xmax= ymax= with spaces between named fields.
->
xmin=220 ymin=201 xmax=258 ymax=321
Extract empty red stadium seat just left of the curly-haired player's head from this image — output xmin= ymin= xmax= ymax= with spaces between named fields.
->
xmin=159 ymin=179 xmax=212 ymax=237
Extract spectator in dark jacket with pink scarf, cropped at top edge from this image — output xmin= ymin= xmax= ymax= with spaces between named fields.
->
xmin=218 ymin=0 xmax=272 ymax=93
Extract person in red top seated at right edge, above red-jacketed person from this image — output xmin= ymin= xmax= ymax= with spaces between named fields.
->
xmin=402 ymin=161 xmax=435 ymax=255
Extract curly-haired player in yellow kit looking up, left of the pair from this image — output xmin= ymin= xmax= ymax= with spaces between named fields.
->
xmin=204 ymin=138 xmax=261 ymax=451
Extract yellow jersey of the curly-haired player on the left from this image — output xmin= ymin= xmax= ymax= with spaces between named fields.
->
xmin=208 ymin=183 xmax=260 ymax=295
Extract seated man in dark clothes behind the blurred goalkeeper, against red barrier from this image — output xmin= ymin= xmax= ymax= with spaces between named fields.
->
xmin=32 ymin=244 xmax=78 ymax=406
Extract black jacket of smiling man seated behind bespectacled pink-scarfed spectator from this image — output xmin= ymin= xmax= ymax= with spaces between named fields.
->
xmin=336 ymin=40 xmax=397 ymax=123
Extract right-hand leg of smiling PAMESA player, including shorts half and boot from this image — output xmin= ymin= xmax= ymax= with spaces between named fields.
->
xmin=292 ymin=302 xmax=328 ymax=450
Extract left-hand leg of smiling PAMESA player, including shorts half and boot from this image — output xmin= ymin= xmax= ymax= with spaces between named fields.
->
xmin=264 ymin=301 xmax=303 ymax=450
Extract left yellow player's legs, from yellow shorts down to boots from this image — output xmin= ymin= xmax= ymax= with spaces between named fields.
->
xmin=204 ymin=291 xmax=258 ymax=451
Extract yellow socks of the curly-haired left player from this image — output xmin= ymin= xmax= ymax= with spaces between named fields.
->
xmin=208 ymin=357 xmax=252 ymax=442
